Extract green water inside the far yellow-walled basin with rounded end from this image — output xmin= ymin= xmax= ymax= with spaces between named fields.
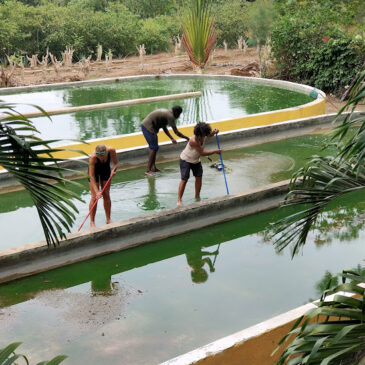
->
xmin=0 ymin=77 xmax=313 ymax=144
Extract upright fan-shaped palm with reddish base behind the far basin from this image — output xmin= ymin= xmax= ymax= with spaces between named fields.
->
xmin=182 ymin=0 xmax=217 ymax=68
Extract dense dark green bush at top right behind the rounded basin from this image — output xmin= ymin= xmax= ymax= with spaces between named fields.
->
xmin=271 ymin=0 xmax=365 ymax=92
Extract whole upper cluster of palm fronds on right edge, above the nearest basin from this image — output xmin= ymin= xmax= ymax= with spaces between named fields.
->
xmin=273 ymin=71 xmax=365 ymax=256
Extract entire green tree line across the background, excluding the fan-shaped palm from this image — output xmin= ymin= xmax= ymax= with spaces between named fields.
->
xmin=0 ymin=0 xmax=365 ymax=94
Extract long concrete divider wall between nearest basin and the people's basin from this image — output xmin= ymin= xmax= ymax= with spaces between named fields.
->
xmin=0 ymin=180 xmax=289 ymax=282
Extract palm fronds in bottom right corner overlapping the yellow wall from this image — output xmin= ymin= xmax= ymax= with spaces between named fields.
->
xmin=278 ymin=272 xmax=365 ymax=365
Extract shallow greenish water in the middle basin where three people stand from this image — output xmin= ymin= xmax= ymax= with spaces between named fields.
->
xmin=0 ymin=135 xmax=331 ymax=249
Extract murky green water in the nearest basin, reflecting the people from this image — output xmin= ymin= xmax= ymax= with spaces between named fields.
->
xmin=0 ymin=189 xmax=365 ymax=365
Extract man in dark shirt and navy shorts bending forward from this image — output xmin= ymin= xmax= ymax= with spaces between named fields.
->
xmin=142 ymin=106 xmax=189 ymax=176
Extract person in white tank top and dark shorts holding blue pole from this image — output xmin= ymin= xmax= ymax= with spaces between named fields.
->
xmin=177 ymin=122 xmax=221 ymax=205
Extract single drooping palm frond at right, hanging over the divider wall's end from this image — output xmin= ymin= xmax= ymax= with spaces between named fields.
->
xmin=273 ymin=157 xmax=365 ymax=256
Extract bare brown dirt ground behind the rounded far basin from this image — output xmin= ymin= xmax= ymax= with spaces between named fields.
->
xmin=3 ymin=48 xmax=365 ymax=113
